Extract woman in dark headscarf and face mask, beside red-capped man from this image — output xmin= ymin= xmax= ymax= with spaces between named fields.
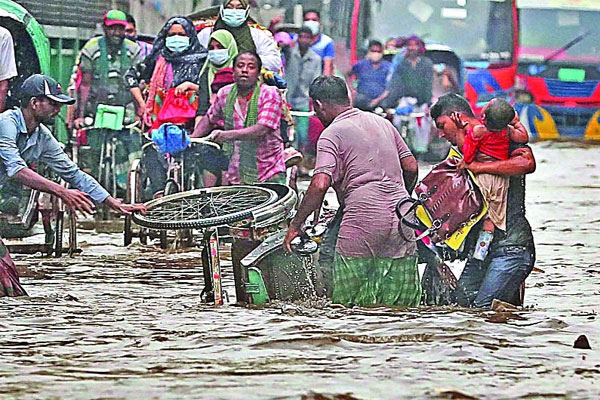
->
xmin=125 ymin=17 xmax=207 ymax=126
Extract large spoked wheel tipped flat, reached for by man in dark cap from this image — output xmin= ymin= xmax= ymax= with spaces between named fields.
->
xmin=133 ymin=186 xmax=277 ymax=229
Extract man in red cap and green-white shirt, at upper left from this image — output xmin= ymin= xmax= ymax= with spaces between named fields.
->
xmin=74 ymin=10 xmax=141 ymax=194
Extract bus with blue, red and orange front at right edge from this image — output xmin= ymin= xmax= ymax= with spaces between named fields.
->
xmin=515 ymin=0 xmax=600 ymax=140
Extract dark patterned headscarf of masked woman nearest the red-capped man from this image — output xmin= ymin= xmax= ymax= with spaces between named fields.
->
xmin=150 ymin=16 xmax=207 ymax=86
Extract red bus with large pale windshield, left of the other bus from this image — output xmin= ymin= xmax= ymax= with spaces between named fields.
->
xmin=364 ymin=0 xmax=518 ymax=112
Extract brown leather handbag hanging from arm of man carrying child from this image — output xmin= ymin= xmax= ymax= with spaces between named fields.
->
xmin=396 ymin=157 xmax=485 ymax=243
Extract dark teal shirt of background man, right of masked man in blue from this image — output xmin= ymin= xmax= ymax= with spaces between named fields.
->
xmin=382 ymin=57 xmax=433 ymax=108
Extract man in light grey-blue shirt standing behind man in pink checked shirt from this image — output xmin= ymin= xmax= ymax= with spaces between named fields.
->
xmin=286 ymin=26 xmax=322 ymax=152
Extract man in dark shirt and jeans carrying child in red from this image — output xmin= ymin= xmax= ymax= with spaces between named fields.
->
xmin=431 ymin=94 xmax=535 ymax=307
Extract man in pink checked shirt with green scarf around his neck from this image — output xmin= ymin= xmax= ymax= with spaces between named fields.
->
xmin=192 ymin=52 xmax=285 ymax=184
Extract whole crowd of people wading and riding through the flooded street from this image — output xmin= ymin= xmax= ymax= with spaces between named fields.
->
xmin=0 ymin=0 xmax=535 ymax=307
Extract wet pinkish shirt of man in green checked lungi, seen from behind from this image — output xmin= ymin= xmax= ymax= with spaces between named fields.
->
xmin=315 ymin=109 xmax=416 ymax=258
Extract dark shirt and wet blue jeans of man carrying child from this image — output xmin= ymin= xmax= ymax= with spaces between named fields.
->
xmin=456 ymin=142 xmax=535 ymax=307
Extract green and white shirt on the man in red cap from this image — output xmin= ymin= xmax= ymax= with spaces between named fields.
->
xmin=79 ymin=36 xmax=141 ymax=121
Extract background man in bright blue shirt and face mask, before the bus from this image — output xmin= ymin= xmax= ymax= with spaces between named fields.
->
xmin=348 ymin=40 xmax=392 ymax=111
